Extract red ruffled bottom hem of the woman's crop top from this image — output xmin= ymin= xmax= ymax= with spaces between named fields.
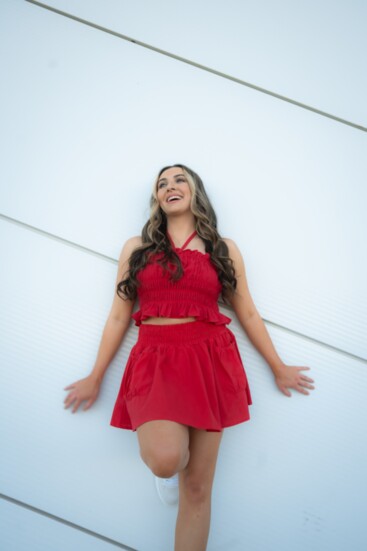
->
xmin=131 ymin=302 xmax=232 ymax=326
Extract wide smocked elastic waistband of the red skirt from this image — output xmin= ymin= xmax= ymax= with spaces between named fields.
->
xmin=138 ymin=321 xmax=229 ymax=345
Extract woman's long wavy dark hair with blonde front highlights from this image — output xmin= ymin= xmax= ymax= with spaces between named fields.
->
xmin=117 ymin=164 xmax=237 ymax=303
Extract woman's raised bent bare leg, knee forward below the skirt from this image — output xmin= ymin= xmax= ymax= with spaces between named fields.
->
xmin=136 ymin=421 xmax=190 ymax=478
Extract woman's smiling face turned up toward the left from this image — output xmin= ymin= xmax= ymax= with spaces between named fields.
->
xmin=156 ymin=167 xmax=192 ymax=215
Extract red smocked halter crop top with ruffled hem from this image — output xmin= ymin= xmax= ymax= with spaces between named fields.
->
xmin=132 ymin=231 xmax=232 ymax=325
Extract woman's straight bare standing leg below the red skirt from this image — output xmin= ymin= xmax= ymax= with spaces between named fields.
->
xmin=175 ymin=428 xmax=222 ymax=551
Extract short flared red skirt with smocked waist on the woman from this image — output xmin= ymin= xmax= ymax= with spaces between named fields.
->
xmin=111 ymin=321 xmax=252 ymax=431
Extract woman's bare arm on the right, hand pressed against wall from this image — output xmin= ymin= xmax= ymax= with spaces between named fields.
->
xmin=224 ymin=239 xmax=314 ymax=396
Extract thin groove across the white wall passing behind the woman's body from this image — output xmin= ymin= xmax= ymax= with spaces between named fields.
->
xmin=0 ymin=213 xmax=367 ymax=365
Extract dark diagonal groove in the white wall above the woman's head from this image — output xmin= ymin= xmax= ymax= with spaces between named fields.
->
xmin=26 ymin=0 xmax=367 ymax=132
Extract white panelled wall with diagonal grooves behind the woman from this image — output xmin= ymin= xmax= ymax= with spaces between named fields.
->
xmin=0 ymin=0 xmax=367 ymax=551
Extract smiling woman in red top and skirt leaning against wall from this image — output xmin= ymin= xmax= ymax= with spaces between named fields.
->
xmin=65 ymin=165 xmax=314 ymax=551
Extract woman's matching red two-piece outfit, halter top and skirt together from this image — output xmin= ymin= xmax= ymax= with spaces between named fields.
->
xmin=111 ymin=232 xmax=252 ymax=431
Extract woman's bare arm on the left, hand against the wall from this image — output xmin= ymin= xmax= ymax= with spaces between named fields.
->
xmin=64 ymin=237 xmax=141 ymax=413
